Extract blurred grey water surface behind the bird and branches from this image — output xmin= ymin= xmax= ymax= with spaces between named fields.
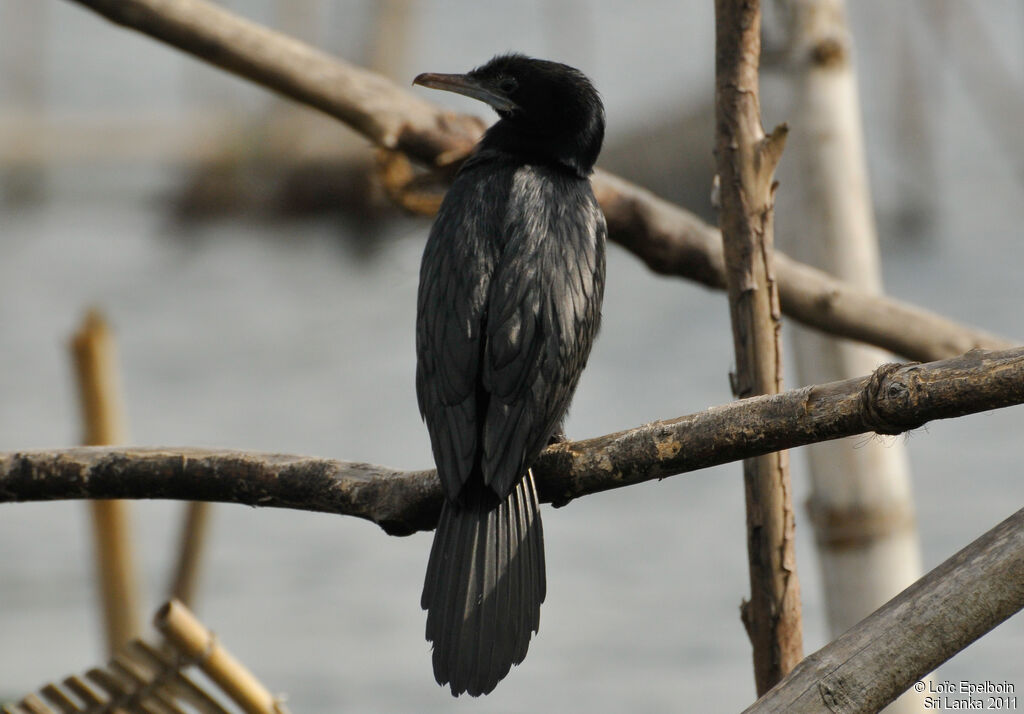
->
xmin=0 ymin=0 xmax=1024 ymax=712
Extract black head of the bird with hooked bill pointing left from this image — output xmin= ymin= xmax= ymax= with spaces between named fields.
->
xmin=413 ymin=54 xmax=604 ymax=176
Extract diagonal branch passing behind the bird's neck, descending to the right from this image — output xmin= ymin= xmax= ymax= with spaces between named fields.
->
xmin=66 ymin=0 xmax=1013 ymax=361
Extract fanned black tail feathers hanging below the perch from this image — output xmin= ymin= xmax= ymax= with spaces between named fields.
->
xmin=421 ymin=471 xmax=547 ymax=697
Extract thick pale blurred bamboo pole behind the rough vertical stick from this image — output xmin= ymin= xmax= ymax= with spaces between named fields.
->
xmin=784 ymin=0 xmax=924 ymax=714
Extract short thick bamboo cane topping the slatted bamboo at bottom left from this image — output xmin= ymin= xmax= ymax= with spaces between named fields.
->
xmin=154 ymin=600 xmax=287 ymax=714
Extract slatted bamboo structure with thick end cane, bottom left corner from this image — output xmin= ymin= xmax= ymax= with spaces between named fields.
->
xmin=0 ymin=600 xmax=288 ymax=714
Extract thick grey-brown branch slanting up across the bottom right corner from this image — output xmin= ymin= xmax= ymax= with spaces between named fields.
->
xmin=745 ymin=509 xmax=1024 ymax=714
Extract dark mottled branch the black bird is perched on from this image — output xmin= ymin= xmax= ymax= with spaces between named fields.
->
xmin=0 ymin=347 xmax=1024 ymax=535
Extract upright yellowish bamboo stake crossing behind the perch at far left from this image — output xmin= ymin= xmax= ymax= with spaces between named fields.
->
xmin=72 ymin=309 xmax=139 ymax=654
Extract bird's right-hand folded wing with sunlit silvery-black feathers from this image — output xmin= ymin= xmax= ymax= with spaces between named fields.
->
xmin=480 ymin=167 xmax=605 ymax=497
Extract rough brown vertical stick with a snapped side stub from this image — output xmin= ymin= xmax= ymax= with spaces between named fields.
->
xmin=715 ymin=0 xmax=803 ymax=695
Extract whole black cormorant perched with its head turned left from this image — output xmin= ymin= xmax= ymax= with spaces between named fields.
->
xmin=414 ymin=54 xmax=607 ymax=697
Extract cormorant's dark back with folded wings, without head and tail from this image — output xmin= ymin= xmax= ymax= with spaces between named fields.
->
xmin=417 ymin=152 xmax=606 ymax=500
